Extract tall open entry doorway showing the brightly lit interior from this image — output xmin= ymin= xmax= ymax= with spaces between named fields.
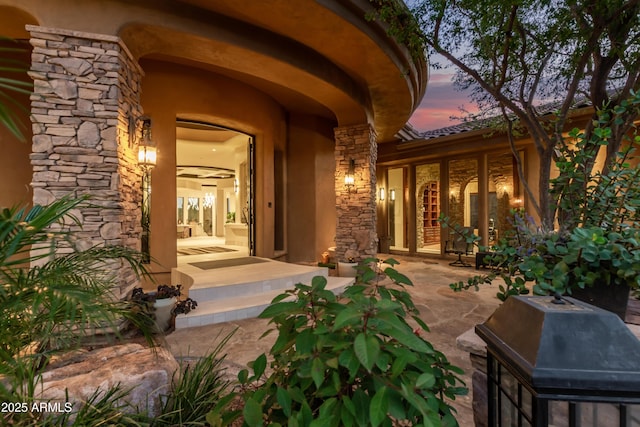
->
xmin=176 ymin=119 xmax=255 ymax=259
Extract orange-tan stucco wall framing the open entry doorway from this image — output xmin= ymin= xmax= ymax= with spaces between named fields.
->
xmin=140 ymin=59 xmax=286 ymax=272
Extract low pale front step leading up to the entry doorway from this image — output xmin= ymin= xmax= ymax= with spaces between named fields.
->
xmin=176 ymin=277 xmax=354 ymax=329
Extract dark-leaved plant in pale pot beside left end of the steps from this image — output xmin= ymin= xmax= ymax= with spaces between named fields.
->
xmin=131 ymin=285 xmax=198 ymax=332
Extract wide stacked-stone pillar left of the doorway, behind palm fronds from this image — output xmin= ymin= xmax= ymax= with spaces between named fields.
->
xmin=27 ymin=26 xmax=142 ymax=297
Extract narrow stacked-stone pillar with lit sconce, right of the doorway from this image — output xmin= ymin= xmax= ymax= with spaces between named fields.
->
xmin=334 ymin=124 xmax=378 ymax=261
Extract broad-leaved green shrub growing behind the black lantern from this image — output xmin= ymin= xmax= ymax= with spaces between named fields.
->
xmin=450 ymin=98 xmax=640 ymax=300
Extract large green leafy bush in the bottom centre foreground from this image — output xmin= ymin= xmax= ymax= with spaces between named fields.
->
xmin=208 ymin=258 xmax=467 ymax=427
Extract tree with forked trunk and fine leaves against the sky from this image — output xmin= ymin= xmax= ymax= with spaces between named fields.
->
xmin=371 ymin=0 xmax=640 ymax=225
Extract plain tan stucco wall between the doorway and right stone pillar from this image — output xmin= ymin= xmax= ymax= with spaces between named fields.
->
xmin=287 ymin=114 xmax=336 ymax=262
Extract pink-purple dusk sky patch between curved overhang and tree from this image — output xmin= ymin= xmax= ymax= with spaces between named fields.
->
xmin=409 ymin=65 xmax=473 ymax=131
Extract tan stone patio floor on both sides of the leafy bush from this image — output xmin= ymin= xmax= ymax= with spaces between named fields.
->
xmin=166 ymin=255 xmax=500 ymax=427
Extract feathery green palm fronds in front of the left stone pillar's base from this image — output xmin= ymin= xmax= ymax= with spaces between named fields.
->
xmin=0 ymin=196 xmax=152 ymax=402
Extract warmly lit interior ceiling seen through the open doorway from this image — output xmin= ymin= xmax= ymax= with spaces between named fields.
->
xmin=176 ymin=121 xmax=250 ymax=185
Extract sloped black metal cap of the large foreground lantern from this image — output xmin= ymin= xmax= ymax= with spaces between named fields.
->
xmin=476 ymin=296 xmax=640 ymax=397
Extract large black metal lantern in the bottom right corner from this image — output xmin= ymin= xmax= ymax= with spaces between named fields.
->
xmin=476 ymin=296 xmax=640 ymax=427
